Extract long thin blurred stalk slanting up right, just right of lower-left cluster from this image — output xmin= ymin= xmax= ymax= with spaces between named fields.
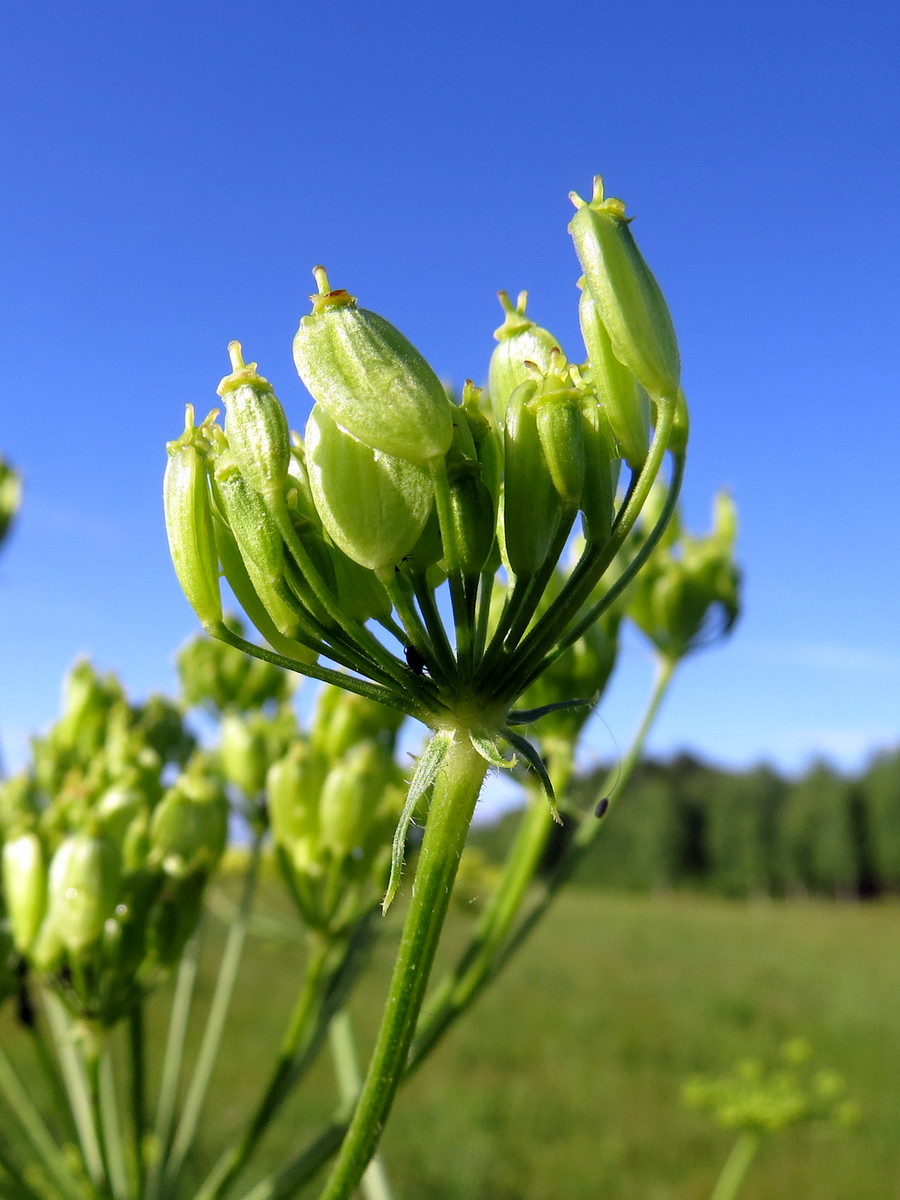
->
xmin=162 ymin=832 xmax=262 ymax=1196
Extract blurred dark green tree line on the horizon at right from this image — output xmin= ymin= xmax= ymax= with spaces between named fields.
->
xmin=476 ymin=749 xmax=900 ymax=899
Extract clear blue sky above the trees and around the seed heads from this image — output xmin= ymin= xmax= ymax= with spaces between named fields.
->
xmin=0 ymin=0 xmax=900 ymax=769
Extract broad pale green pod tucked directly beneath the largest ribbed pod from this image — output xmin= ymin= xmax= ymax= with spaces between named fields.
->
xmin=306 ymin=406 xmax=433 ymax=571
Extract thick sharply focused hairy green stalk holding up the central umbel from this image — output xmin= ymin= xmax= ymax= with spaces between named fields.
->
xmin=322 ymin=730 xmax=487 ymax=1200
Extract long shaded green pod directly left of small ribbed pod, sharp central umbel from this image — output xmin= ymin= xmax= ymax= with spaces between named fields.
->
xmin=503 ymin=379 xmax=560 ymax=576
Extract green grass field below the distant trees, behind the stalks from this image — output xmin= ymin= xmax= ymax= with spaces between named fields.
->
xmin=162 ymin=892 xmax=900 ymax=1200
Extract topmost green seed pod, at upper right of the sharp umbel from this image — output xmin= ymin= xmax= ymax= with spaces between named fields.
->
xmin=569 ymin=175 xmax=680 ymax=400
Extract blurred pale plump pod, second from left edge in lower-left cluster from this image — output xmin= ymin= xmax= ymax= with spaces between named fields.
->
xmin=47 ymin=833 xmax=121 ymax=954
